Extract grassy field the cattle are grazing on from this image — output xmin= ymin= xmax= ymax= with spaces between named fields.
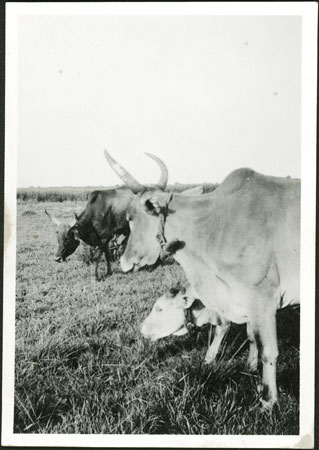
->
xmin=14 ymin=200 xmax=299 ymax=434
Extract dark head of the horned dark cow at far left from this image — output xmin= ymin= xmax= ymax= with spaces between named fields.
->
xmin=45 ymin=210 xmax=80 ymax=262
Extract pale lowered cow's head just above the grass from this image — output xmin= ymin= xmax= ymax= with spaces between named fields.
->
xmin=141 ymin=287 xmax=209 ymax=341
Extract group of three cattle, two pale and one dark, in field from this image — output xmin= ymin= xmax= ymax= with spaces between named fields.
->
xmin=46 ymin=150 xmax=300 ymax=410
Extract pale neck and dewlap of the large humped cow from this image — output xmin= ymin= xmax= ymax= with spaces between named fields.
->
xmin=165 ymin=194 xmax=260 ymax=323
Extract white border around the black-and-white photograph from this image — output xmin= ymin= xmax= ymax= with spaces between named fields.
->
xmin=1 ymin=2 xmax=318 ymax=448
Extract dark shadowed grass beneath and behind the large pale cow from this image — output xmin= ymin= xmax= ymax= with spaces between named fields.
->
xmin=150 ymin=308 xmax=300 ymax=398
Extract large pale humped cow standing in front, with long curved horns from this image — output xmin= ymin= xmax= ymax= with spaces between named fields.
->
xmin=105 ymin=151 xmax=300 ymax=408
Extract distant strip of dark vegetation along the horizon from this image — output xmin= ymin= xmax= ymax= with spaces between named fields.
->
xmin=17 ymin=183 xmax=217 ymax=202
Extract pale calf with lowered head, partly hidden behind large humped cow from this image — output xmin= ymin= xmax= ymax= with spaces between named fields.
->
xmin=141 ymin=285 xmax=258 ymax=371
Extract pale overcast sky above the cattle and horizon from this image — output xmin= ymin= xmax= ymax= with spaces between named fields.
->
xmin=18 ymin=15 xmax=301 ymax=186
